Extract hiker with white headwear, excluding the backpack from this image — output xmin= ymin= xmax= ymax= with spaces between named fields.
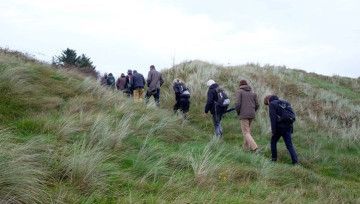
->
xmin=205 ymin=79 xmax=226 ymax=138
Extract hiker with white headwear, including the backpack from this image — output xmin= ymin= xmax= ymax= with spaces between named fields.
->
xmin=205 ymin=79 xmax=230 ymax=138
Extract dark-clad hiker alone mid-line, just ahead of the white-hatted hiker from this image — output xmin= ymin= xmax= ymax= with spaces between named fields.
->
xmin=173 ymin=79 xmax=190 ymax=118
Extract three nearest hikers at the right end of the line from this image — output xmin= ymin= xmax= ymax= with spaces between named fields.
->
xmin=205 ymin=79 xmax=299 ymax=165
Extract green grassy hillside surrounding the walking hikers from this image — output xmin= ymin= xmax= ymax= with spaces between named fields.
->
xmin=0 ymin=50 xmax=360 ymax=203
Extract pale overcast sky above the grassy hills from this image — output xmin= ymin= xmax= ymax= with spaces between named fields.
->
xmin=0 ymin=0 xmax=360 ymax=77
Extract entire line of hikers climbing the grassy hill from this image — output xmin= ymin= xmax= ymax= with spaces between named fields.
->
xmin=101 ymin=65 xmax=299 ymax=164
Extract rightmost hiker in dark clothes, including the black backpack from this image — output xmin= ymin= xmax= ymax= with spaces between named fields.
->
xmin=264 ymin=95 xmax=299 ymax=164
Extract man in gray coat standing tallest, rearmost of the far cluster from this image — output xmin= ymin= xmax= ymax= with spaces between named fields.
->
xmin=145 ymin=65 xmax=164 ymax=106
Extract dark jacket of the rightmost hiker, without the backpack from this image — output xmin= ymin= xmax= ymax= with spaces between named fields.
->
xmin=269 ymin=95 xmax=293 ymax=135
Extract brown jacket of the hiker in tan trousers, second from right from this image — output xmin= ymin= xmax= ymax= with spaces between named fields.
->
xmin=235 ymin=85 xmax=259 ymax=119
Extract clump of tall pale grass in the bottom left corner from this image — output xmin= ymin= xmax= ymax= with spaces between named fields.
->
xmin=0 ymin=130 xmax=49 ymax=203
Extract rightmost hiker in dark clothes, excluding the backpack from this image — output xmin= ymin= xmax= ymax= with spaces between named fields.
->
xmin=264 ymin=95 xmax=299 ymax=164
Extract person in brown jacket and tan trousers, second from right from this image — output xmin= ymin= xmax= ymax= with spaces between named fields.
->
xmin=235 ymin=80 xmax=259 ymax=151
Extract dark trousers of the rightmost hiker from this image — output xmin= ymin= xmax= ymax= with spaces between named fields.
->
xmin=271 ymin=128 xmax=299 ymax=164
